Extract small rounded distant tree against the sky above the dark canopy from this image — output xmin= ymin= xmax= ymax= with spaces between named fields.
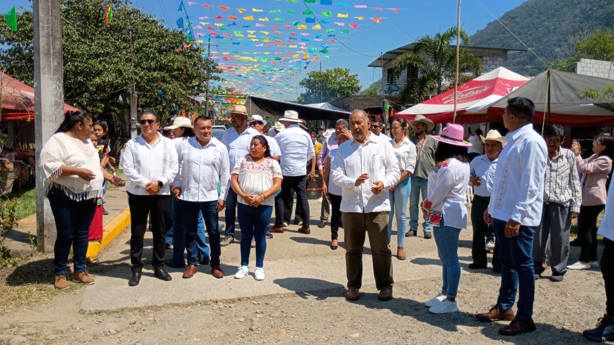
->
xmin=298 ymin=68 xmax=360 ymax=103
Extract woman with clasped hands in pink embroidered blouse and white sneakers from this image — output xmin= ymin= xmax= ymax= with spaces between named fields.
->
xmin=230 ymin=135 xmax=282 ymax=280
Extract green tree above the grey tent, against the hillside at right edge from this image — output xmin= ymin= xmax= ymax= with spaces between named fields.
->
xmin=553 ymin=31 xmax=614 ymax=72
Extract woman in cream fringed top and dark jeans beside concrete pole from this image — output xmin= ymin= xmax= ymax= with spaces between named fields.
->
xmin=40 ymin=112 xmax=121 ymax=289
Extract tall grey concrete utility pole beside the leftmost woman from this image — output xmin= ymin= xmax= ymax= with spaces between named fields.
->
xmin=32 ymin=0 xmax=64 ymax=252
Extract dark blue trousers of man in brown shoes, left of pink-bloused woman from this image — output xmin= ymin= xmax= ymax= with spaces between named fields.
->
xmin=179 ymin=200 xmax=221 ymax=267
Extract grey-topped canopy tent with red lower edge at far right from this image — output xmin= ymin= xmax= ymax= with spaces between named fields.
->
xmin=488 ymin=69 xmax=614 ymax=126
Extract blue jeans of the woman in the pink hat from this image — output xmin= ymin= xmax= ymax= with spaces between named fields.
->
xmin=434 ymin=219 xmax=461 ymax=297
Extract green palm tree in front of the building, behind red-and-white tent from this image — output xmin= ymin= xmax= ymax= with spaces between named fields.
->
xmin=393 ymin=27 xmax=481 ymax=103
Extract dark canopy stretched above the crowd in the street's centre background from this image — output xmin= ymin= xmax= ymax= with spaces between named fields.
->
xmin=245 ymin=96 xmax=350 ymax=121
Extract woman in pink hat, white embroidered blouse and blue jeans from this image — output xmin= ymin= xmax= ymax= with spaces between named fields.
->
xmin=423 ymin=124 xmax=471 ymax=314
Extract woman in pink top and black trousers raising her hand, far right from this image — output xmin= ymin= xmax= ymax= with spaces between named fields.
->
xmin=567 ymin=134 xmax=614 ymax=270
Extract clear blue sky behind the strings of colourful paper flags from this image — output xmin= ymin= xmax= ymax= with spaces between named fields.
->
xmin=0 ymin=0 xmax=524 ymax=100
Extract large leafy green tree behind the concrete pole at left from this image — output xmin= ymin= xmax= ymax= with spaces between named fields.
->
xmin=0 ymin=0 xmax=218 ymax=136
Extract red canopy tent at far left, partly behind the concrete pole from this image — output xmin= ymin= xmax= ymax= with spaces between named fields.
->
xmin=0 ymin=71 xmax=79 ymax=121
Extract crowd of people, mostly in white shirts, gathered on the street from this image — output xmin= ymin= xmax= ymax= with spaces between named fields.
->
xmin=41 ymin=97 xmax=614 ymax=340
